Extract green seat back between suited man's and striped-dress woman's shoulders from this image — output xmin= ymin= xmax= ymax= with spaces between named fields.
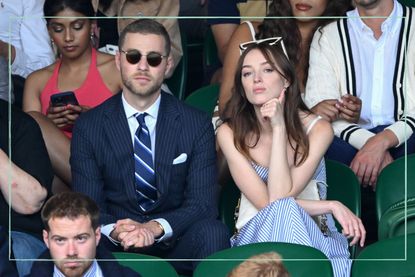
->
xmin=184 ymin=84 xmax=219 ymax=115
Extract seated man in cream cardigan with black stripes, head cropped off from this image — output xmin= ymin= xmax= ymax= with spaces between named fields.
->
xmin=305 ymin=0 xmax=415 ymax=189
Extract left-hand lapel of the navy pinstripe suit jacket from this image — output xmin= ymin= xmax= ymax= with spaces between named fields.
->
xmin=104 ymin=93 xmax=136 ymax=203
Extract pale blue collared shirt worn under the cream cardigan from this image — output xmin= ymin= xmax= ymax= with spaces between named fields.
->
xmin=347 ymin=0 xmax=403 ymax=129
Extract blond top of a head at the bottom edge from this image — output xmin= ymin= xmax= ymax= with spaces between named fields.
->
xmin=228 ymin=252 xmax=290 ymax=277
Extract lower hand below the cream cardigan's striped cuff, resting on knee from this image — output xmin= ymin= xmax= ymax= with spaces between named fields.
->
xmin=350 ymin=130 xmax=397 ymax=190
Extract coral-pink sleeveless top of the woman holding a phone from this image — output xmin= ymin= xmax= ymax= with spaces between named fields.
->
xmin=40 ymin=48 xmax=114 ymax=137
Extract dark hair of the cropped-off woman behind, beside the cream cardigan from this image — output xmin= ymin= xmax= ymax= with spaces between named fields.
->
xmin=257 ymin=0 xmax=353 ymax=86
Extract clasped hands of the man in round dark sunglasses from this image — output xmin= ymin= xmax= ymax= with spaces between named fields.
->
xmin=110 ymin=218 xmax=162 ymax=250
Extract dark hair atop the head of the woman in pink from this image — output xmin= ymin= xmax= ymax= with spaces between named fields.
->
xmin=43 ymin=0 xmax=95 ymax=22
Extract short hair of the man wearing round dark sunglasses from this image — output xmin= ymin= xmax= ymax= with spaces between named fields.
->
xmin=118 ymin=18 xmax=171 ymax=56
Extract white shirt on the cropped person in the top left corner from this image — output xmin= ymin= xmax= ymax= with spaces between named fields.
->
xmin=0 ymin=0 xmax=54 ymax=78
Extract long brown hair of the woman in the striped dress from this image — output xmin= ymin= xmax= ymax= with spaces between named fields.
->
xmin=221 ymin=42 xmax=311 ymax=166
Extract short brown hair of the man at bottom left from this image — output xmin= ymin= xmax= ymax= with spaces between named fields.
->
xmin=41 ymin=191 xmax=100 ymax=232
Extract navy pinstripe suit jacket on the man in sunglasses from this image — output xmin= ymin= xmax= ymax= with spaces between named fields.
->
xmin=70 ymin=92 xmax=217 ymax=239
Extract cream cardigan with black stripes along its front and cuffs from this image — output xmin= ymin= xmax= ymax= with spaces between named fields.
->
xmin=304 ymin=3 xmax=415 ymax=149
